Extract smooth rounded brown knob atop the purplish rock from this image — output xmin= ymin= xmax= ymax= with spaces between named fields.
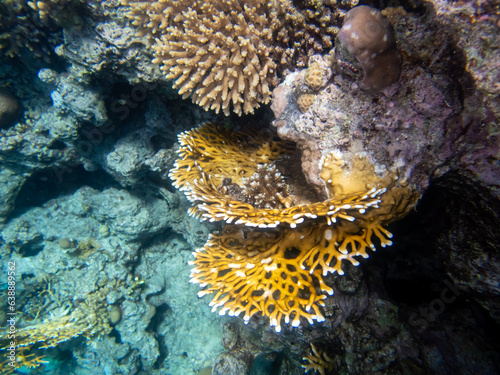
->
xmin=335 ymin=5 xmax=401 ymax=94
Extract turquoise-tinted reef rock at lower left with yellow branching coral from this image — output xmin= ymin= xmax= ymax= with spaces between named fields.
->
xmin=0 ymin=187 xmax=220 ymax=374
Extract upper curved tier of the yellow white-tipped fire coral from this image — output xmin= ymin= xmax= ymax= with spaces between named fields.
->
xmin=169 ymin=124 xmax=383 ymax=228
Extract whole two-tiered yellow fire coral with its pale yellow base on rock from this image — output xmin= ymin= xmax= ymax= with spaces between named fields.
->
xmin=170 ymin=124 xmax=416 ymax=331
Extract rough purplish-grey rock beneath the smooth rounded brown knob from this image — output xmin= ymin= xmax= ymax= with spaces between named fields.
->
xmin=274 ymin=65 xmax=461 ymax=197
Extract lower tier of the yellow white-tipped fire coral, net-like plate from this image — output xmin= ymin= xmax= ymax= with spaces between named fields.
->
xmin=191 ymin=220 xmax=392 ymax=332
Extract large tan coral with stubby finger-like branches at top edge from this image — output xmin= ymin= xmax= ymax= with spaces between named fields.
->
xmin=122 ymin=0 xmax=357 ymax=115
